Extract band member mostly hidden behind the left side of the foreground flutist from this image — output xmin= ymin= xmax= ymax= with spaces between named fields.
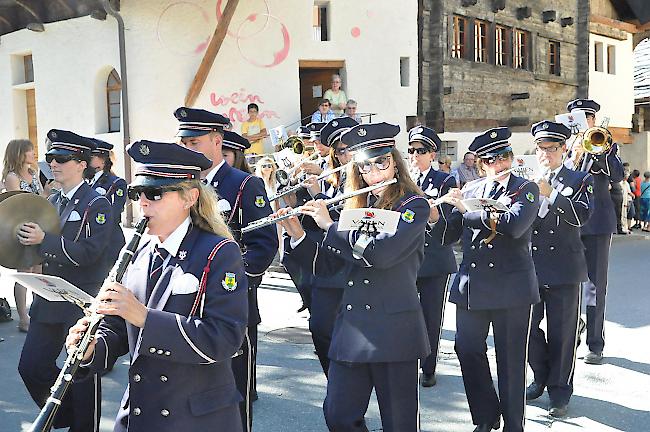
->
xmin=282 ymin=117 xmax=358 ymax=376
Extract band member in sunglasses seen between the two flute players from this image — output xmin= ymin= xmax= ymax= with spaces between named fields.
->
xmin=408 ymin=126 xmax=457 ymax=387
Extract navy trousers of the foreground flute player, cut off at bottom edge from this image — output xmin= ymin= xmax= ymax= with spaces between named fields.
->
xmin=323 ymin=360 xmax=420 ymax=432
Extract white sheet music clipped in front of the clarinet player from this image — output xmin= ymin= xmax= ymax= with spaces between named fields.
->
xmin=12 ymin=272 xmax=95 ymax=305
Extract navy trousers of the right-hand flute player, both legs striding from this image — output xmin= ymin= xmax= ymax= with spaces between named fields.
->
xmin=455 ymin=306 xmax=531 ymax=432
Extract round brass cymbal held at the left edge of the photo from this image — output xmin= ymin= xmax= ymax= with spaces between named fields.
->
xmin=0 ymin=191 xmax=61 ymax=269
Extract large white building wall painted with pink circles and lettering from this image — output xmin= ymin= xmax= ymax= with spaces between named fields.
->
xmin=0 ymin=0 xmax=418 ymax=179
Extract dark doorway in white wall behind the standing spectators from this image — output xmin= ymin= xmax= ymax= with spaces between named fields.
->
xmin=298 ymin=60 xmax=347 ymax=125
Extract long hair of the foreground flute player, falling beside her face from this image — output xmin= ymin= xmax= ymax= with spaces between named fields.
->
xmin=345 ymin=148 xmax=424 ymax=210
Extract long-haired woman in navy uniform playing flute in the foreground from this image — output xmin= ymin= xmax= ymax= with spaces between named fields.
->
xmin=279 ymin=123 xmax=429 ymax=432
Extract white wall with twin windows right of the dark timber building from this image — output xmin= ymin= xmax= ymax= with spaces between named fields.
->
xmin=589 ymin=33 xmax=634 ymax=128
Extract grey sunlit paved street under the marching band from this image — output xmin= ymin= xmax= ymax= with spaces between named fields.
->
xmin=0 ymin=235 xmax=650 ymax=432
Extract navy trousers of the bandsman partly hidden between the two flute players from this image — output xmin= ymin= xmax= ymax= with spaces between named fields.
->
xmin=417 ymin=275 xmax=449 ymax=374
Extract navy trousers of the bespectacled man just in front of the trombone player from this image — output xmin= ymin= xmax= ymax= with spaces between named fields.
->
xmin=528 ymin=283 xmax=580 ymax=406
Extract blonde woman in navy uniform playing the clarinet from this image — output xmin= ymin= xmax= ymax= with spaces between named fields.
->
xmin=67 ymin=141 xmax=248 ymax=432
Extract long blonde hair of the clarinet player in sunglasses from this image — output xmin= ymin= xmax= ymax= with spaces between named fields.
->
xmin=174 ymin=180 xmax=233 ymax=239
